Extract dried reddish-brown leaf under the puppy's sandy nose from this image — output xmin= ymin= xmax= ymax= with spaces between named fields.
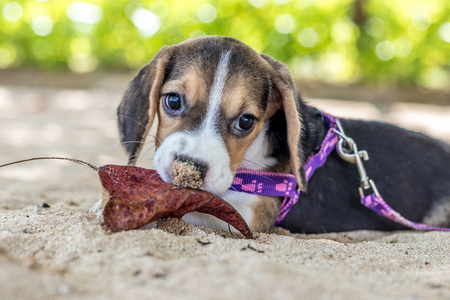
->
xmin=98 ymin=165 xmax=253 ymax=238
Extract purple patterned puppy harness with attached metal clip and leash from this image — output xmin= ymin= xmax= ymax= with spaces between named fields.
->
xmin=230 ymin=113 xmax=450 ymax=231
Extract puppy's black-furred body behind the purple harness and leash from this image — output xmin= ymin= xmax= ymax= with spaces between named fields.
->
xmin=280 ymin=119 xmax=450 ymax=233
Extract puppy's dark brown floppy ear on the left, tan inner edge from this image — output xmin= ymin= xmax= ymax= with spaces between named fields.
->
xmin=117 ymin=47 xmax=173 ymax=165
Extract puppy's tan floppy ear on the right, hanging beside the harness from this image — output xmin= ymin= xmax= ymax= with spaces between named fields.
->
xmin=261 ymin=54 xmax=306 ymax=191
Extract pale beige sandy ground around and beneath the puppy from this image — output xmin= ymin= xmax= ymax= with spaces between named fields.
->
xmin=0 ymin=74 xmax=450 ymax=299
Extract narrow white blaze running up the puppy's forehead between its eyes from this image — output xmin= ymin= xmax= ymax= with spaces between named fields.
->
xmin=202 ymin=51 xmax=230 ymax=130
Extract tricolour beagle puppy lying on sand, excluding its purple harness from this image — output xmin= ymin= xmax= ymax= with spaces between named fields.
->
xmin=110 ymin=36 xmax=450 ymax=233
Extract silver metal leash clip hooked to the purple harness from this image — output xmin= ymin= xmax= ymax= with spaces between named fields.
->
xmin=333 ymin=119 xmax=380 ymax=198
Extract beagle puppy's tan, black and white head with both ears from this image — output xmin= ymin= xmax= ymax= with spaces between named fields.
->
xmin=118 ymin=37 xmax=304 ymax=195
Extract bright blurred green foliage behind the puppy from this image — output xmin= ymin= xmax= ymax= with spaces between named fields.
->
xmin=0 ymin=0 xmax=450 ymax=88
